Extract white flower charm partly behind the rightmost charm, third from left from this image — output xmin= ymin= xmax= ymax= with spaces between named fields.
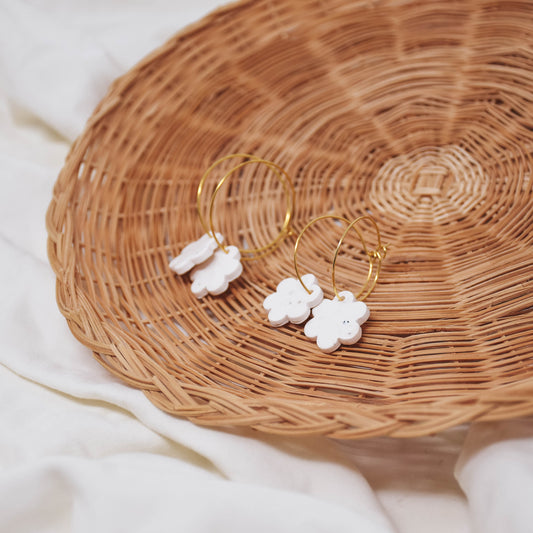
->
xmin=263 ymin=274 xmax=324 ymax=327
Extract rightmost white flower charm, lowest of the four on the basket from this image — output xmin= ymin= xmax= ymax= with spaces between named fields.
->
xmin=304 ymin=291 xmax=370 ymax=353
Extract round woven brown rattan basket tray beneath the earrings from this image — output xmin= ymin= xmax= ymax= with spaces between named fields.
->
xmin=47 ymin=0 xmax=533 ymax=438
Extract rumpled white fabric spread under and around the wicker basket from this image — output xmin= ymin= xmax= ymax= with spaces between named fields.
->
xmin=0 ymin=0 xmax=533 ymax=533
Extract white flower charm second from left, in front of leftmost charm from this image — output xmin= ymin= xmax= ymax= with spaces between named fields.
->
xmin=191 ymin=246 xmax=242 ymax=298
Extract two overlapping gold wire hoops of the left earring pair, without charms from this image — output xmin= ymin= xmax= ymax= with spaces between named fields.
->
xmin=196 ymin=154 xmax=295 ymax=261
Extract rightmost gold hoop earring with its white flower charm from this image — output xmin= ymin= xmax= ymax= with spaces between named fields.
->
xmin=302 ymin=216 xmax=387 ymax=353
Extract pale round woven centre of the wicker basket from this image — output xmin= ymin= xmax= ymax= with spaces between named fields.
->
xmin=370 ymin=145 xmax=488 ymax=223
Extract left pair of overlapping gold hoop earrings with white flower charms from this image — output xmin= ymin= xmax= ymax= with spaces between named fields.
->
xmin=169 ymin=154 xmax=294 ymax=298
